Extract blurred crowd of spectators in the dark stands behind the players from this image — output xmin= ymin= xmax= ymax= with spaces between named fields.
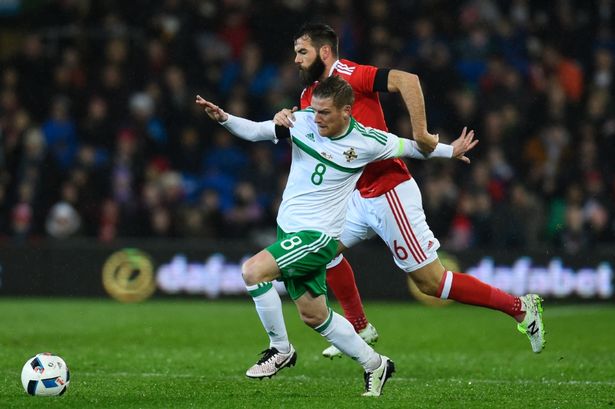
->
xmin=0 ymin=0 xmax=615 ymax=253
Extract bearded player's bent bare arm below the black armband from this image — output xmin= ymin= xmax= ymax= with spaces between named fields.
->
xmin=387 ymin=70 xmax=439 ymax=152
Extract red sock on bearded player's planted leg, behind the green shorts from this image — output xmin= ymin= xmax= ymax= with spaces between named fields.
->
xmin=327 ymin=258 xmax=367 ymax=332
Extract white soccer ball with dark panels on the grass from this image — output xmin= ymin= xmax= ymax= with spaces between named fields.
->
xmin=21 ymin=352 xmax=70 ymax=396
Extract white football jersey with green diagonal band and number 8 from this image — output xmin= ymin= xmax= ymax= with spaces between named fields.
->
xmin=276 ymin=108 xmax=400 ymax=238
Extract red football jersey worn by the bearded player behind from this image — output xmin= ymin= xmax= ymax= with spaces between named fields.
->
xmin=301 ymin=59 xmax=412 ymax=197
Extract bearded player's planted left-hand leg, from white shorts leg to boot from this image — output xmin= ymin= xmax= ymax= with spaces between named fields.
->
xmin=322 ymin=190 xmax=378 ymax=358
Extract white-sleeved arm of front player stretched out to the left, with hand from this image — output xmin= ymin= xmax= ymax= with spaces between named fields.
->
xmin=196 ymin=95 xmax=277 ymax=142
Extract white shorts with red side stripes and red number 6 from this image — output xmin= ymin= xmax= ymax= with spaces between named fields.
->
xmin=340 ymin=179 xmax=440 ymax=272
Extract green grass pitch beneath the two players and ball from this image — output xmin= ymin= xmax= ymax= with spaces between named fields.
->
xmin=0 ymin=298 xmax=615 ymax=409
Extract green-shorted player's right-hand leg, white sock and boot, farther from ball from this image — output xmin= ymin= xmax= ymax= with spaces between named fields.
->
xmin=295 ymin=291 xmax=395 ymax=396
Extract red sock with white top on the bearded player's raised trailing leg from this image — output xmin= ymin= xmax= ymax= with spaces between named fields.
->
xmin=437 ymin=271 xmax=523 ymax=318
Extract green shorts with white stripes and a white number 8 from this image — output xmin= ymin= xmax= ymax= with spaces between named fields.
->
xmin=266 ymin=226 xmax=338 ymax=300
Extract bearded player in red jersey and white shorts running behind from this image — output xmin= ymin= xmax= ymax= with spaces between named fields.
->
xmin=274 ymin=24 xmax=544 ymax=357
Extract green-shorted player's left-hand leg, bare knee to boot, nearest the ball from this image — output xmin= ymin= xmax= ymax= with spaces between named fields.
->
xmin=241 ymin=250 xmax=297 ymax=378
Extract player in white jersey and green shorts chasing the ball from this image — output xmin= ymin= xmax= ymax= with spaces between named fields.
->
xmin=196 ymin=77 xmax=477 ymax=396
